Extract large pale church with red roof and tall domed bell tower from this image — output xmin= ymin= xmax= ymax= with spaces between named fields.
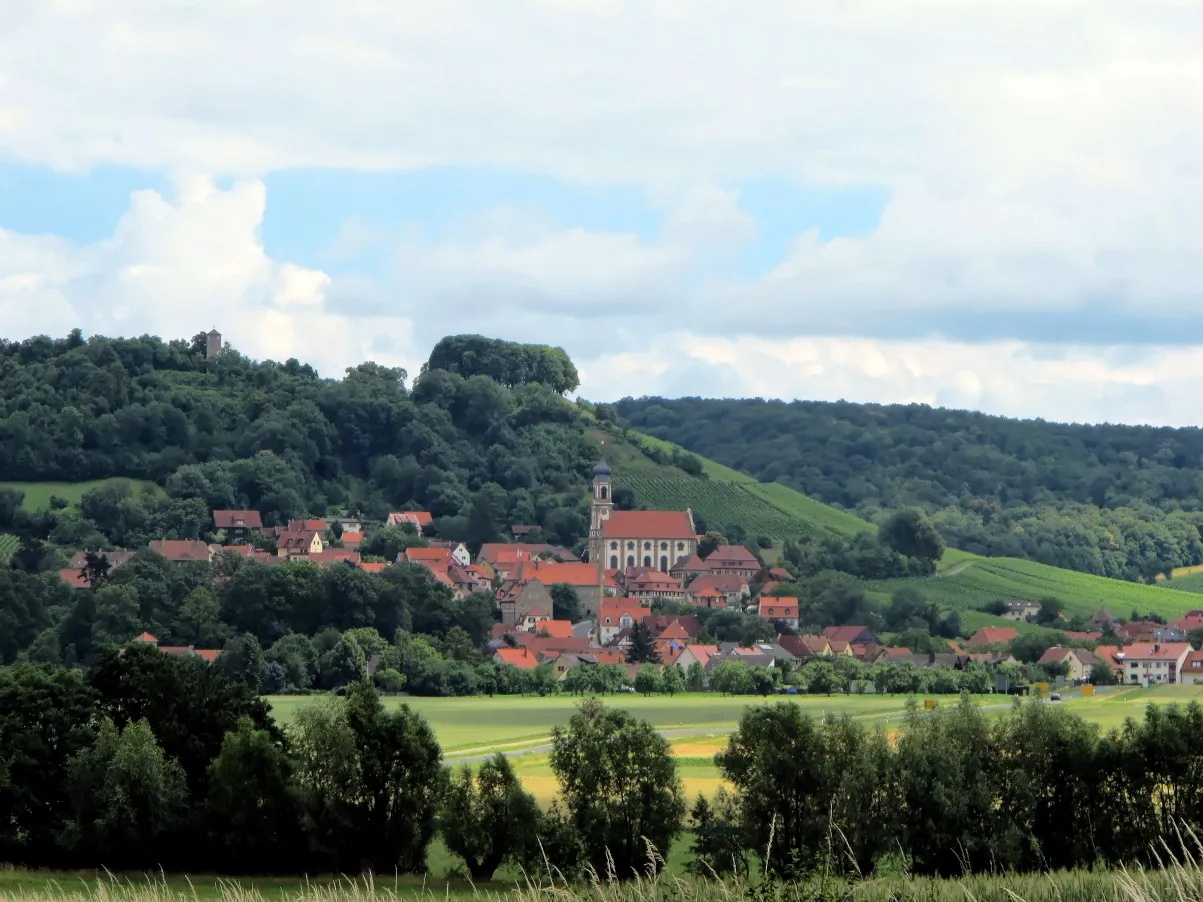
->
xmin=589 ymin=461 xmax=698 ymax=572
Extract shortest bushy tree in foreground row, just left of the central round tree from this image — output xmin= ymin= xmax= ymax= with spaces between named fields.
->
xmin=439 ymin=752 xmax=540 ymax=883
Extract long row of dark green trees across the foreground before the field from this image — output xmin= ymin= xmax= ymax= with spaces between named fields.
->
xmin=7 ymin=648 xmax=1203 ymax=880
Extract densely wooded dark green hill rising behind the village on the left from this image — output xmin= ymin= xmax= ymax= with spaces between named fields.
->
xmin=0 ymin=331 xmax=598 ymax=545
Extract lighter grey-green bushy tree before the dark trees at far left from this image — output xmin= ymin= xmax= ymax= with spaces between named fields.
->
xmin=70 ymin=718 xmax=188 ymax=868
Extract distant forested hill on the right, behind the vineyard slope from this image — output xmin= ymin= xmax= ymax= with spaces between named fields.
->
xmin=616 ymin=398 xmax=1203 ymax=580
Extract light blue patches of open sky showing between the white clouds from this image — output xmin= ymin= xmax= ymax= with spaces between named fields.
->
xmin=0 ymin=162 xmax=887 ymax=279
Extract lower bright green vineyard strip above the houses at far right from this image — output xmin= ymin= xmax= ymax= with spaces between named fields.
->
xmin=867 ymin=551 xmax=1199 ymax=625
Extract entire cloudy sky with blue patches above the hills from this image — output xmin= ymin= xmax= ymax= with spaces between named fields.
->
xmin=0 ymin=0 xmax=1203 ymax=425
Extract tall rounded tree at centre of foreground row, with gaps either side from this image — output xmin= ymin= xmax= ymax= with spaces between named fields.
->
xmin=551 ymin=699 xmax=685 ymax=879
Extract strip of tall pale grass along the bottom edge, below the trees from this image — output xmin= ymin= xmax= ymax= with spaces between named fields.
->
xmin=7 ymin=862 xmax=1203 ymax=902
